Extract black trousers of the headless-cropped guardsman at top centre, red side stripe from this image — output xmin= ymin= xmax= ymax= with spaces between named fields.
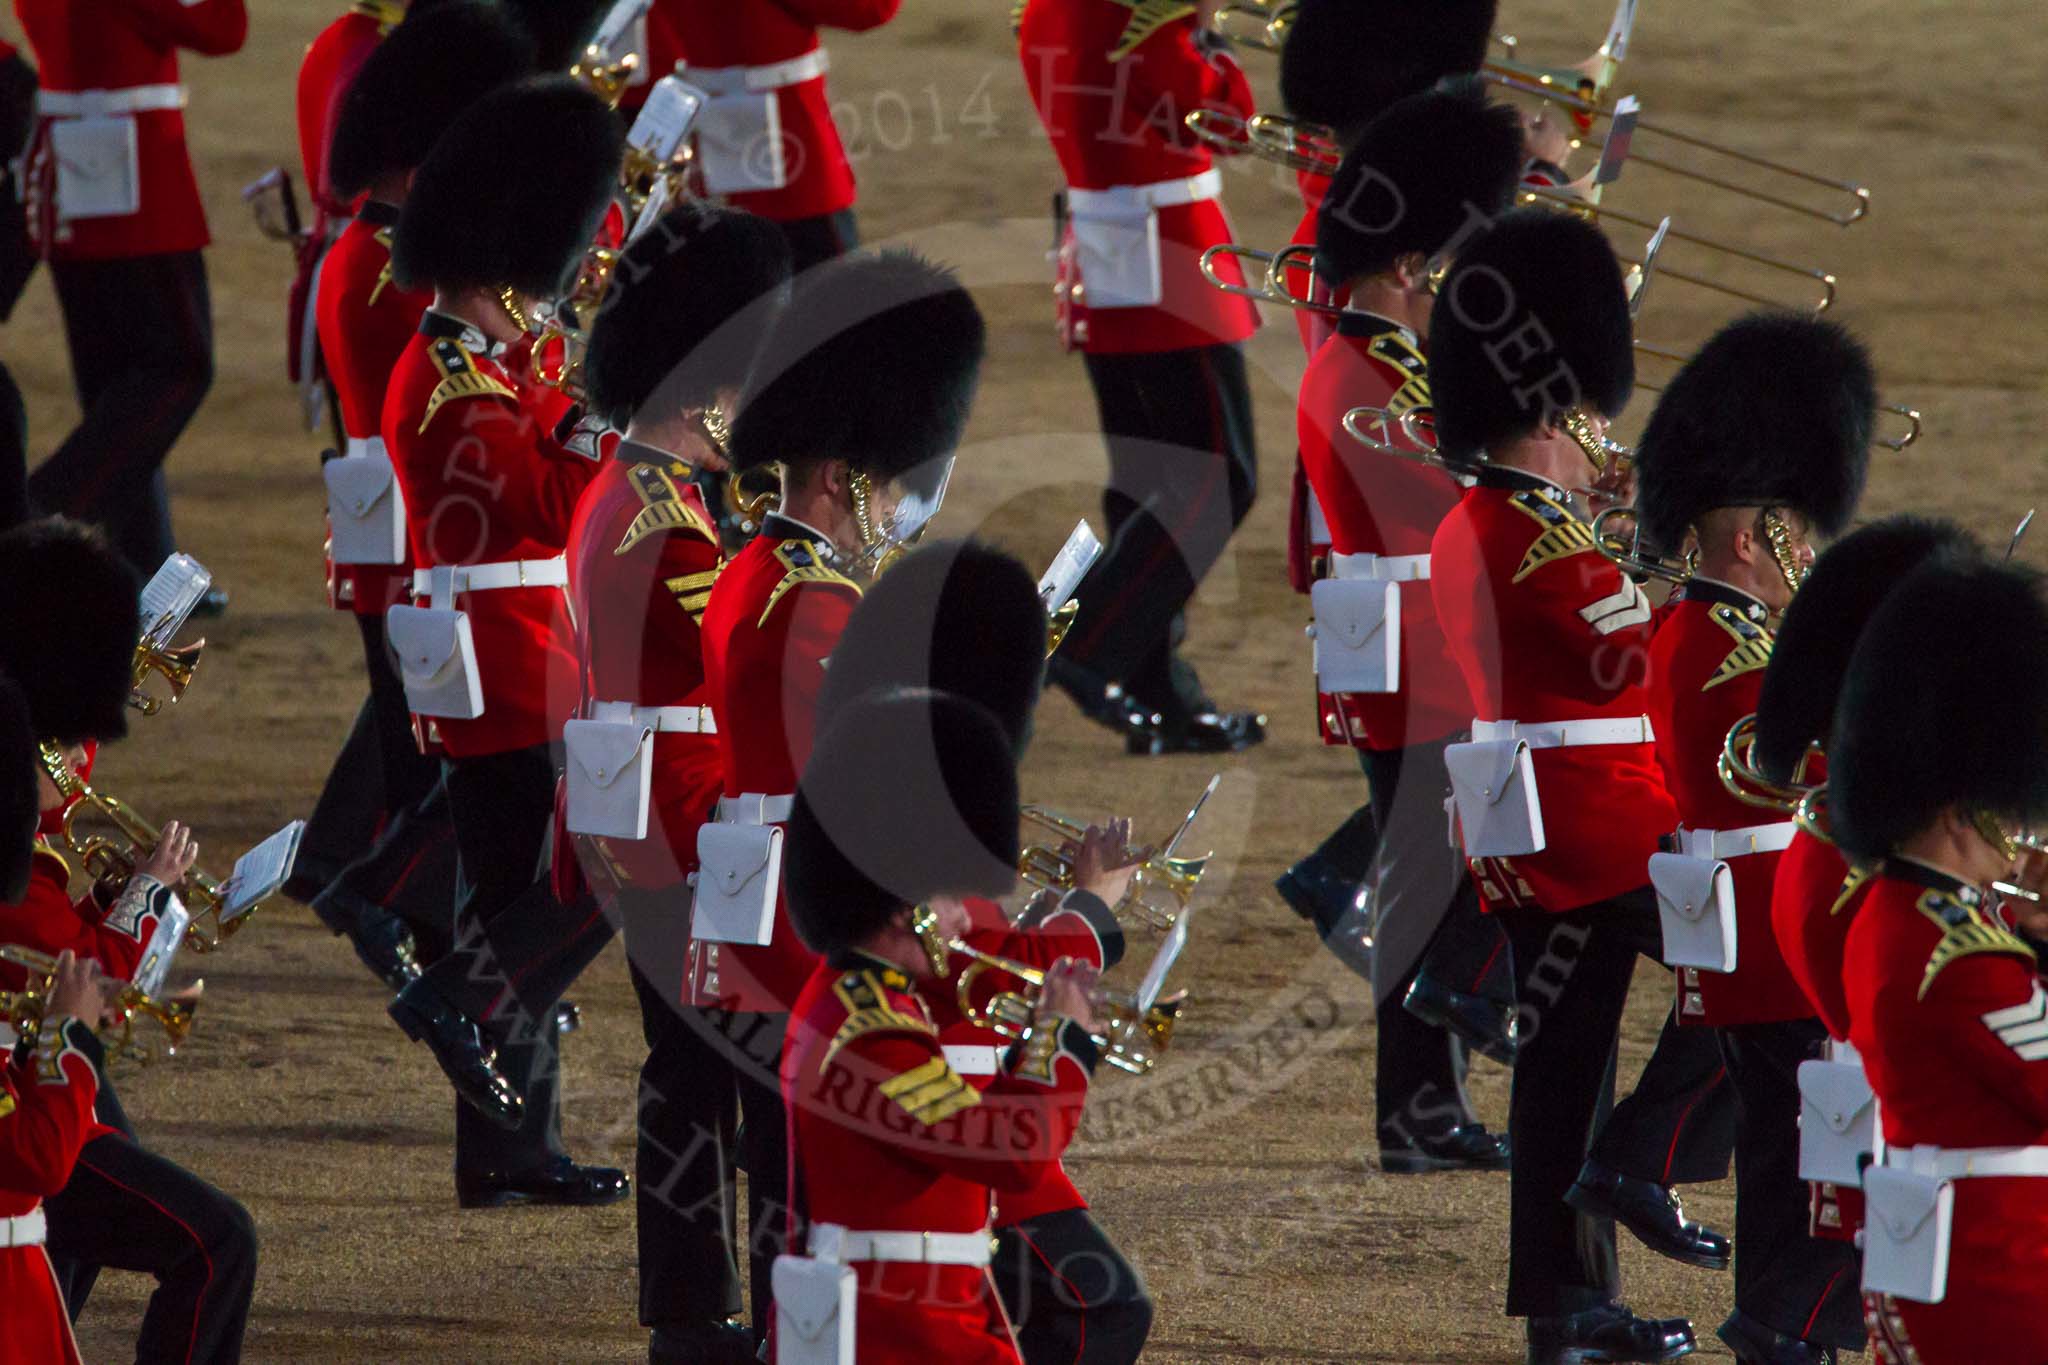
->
xmin=1061 ymin=346 xmax=1257 ymax=714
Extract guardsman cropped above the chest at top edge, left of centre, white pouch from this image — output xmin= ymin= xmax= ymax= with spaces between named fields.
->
xmin=664 ymin=0 xmax=903 ymax=270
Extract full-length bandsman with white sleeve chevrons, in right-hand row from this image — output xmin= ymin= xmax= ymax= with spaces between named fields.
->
xmin=1430 ymin=211 xmax=1700 ymax=1365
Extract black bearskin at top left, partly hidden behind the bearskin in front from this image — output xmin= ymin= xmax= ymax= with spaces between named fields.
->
xmin=328 ymin=0 xmax=535 ymax=199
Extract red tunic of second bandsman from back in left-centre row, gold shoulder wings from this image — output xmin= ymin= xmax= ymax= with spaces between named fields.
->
xmin=383 ymin=311 xmax=598 ymax=759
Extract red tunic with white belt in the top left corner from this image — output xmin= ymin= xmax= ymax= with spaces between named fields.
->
xmin=14 ymin=0 xmax=248 ymax=260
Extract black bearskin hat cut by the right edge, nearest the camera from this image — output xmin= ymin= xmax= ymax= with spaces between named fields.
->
xmin=1827 ymin=559 xmax=2048 ymax=857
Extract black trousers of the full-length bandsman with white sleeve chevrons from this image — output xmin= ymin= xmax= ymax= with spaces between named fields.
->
xmin=1497 ymin=886 xmax=1671 ymax=1318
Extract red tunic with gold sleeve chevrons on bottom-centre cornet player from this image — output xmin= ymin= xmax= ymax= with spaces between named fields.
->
xmin=782 ymin=958 xmax=1094 ymax=1365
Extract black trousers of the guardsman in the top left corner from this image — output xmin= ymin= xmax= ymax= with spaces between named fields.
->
xmin=29 ymin=252 xmax=213 ymax=577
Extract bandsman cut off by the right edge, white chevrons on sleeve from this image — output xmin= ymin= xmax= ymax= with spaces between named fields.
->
xmin=1829 ymin=559 xmax=2048 ymax=1365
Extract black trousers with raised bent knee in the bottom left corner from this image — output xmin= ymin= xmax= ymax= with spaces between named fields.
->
xmin=43 ymin=1134 xmax=256 ymax=1365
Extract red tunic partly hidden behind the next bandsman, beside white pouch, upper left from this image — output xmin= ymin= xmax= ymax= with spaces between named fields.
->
xmin=315 ymin=203 xmax=421 ymax=616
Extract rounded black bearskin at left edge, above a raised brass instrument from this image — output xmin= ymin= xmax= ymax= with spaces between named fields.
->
xmin=0 ymin=516 xmax=141 ymax=745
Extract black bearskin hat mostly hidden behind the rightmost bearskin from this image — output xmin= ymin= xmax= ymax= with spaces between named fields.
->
xmin=1753 ymin=516 xmax=1976 ymax=782
